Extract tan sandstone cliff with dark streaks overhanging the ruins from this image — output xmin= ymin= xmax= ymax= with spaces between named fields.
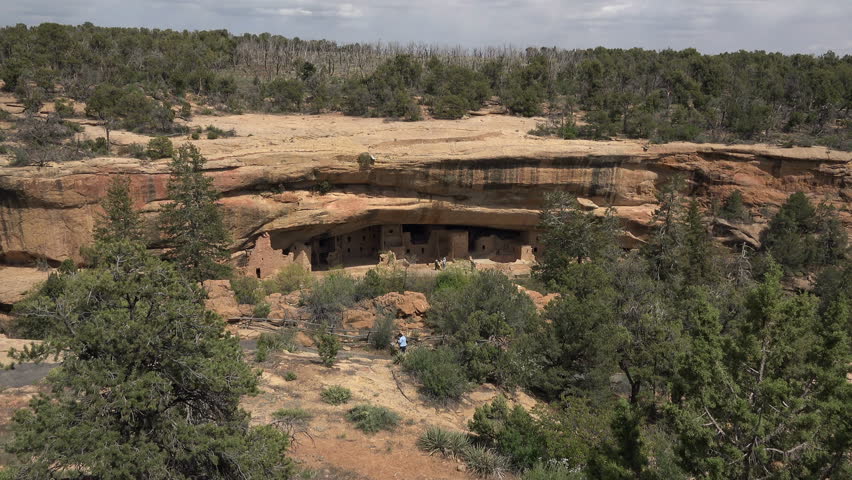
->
xmin=0 ymin=115 xmax=852 ymax=263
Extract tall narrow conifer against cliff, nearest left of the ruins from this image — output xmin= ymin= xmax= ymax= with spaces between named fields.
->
xmin=160 ymin=144 xmax=229 ymax=282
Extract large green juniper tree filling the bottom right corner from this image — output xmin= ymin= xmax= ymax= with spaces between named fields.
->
xmin=667 ymin=260 xmax=852 ymax=480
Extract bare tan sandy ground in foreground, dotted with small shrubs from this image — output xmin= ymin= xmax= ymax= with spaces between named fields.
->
xmin=244 ymin=344 xmax=534 ymax=480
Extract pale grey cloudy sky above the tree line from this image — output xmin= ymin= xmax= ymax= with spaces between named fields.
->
xmin=0 ymin=0 xmax=852 ymax=53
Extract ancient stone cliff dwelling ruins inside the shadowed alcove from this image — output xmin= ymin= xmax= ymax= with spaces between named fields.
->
xmin=241 ymin=224 xmax=542 ymax=278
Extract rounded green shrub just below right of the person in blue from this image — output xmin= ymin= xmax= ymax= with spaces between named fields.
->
xmin=402 ymin=347 xmax=468 ymax=401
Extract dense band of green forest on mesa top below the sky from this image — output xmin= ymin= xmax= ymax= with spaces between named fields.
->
xmin=0 ymin=23 xmax=852 ymax=150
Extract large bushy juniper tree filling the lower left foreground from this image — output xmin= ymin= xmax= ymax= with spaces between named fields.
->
xmin=6 ymin=240 xmax=292 ymax=479
